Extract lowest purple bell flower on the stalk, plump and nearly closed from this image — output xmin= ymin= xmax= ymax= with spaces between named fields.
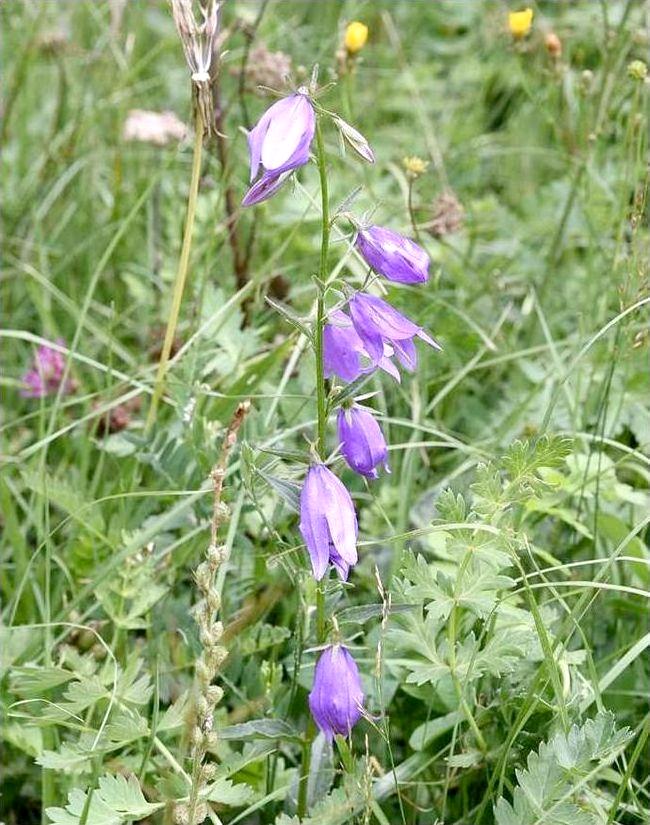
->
xmin=309 ymin=645 xmax=363 ymax=742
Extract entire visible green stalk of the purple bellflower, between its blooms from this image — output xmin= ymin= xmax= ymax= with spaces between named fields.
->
xmin=298 ymin=112 xmax=330 ymax=819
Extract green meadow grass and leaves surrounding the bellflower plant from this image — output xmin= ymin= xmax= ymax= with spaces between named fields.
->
xmin=0 ymin=0 xmax=650 ymax=825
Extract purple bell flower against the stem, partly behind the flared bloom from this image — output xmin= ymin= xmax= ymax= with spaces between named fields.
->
xmin=323 ymin=309 xmax=400 ymax=381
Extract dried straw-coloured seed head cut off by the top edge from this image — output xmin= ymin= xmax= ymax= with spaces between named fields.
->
xmin=171 ymin=0 xmax=220 ymax=133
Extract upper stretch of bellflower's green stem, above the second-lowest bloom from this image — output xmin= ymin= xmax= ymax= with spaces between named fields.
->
xmin=314 ymin=120 xmax=330 ymax=458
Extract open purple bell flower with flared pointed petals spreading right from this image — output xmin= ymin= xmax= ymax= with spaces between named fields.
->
xmin=350 ymin=292 xmax=442 ymax=372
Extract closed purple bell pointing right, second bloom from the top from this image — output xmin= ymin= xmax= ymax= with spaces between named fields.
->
xmin=356 ymin=226 xmax=430 ymax=284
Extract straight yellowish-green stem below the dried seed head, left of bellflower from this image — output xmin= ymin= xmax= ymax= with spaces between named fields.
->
xmin=145 ymin=106 xmax=203 ymax=432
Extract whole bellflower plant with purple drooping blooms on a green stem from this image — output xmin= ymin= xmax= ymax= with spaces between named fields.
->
xmin=243 ymin=74 xmax=440 ymax=804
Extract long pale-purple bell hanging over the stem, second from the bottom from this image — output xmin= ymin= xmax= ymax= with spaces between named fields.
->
xmin=300 ymin=464 xmax=358 ymax=581
